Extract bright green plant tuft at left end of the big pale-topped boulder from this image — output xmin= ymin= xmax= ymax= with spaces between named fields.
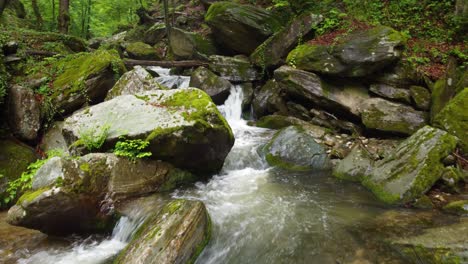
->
xmin=70 ymin=124 xmax=110 ymax=151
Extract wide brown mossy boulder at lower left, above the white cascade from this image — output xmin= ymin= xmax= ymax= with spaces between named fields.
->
xmin=8 ymin=153 xmax=196 ymax=234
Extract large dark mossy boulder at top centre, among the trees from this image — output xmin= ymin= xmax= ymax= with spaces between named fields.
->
xmin=205 ymin=2 xmax=283 ymax=55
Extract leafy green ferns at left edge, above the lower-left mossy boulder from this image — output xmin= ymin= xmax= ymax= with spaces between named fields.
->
xmin=0 ymin=150 xmax=64 ymax=207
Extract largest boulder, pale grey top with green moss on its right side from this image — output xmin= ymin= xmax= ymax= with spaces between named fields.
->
xmin=63 ymin=88 xmax=234 ymax=174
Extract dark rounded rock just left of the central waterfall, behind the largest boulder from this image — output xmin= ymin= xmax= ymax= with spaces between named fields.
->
xmin=189 ymin=67 xmax=232 ymax=105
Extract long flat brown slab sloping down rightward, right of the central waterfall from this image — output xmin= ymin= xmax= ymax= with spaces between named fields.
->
xmin=274 ymin=66 xmax=369 ymax=116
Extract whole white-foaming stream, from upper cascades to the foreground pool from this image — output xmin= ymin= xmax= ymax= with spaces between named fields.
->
xmin=0 ymin=68 xmax=406 ymax=264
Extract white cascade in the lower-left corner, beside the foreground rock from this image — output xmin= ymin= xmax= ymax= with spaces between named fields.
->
xmin=18 ymin=209 xmax=145 ymax=264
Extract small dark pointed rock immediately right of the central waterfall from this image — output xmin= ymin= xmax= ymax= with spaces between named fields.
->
xmin=252 ymin=80 xmax=288 ymax=117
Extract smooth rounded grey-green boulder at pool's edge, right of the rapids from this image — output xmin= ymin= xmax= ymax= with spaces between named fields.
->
xmin=265 ymin=126 xmax=330 ymax=171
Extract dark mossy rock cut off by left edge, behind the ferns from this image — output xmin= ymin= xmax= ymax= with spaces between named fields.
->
xmin=0 ymin=140 xmax=37 ymax=207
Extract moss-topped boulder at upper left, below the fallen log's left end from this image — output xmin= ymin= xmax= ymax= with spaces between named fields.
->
xmin=44 ymin=50 xmax=125 ymax=115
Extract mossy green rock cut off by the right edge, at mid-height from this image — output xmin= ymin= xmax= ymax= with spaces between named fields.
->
xmin=433 ymin=88 xmax=468 ymax=153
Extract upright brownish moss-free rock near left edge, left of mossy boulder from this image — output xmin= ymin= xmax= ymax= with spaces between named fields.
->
xmin=8 ymin=85 xmax=42 ymax=141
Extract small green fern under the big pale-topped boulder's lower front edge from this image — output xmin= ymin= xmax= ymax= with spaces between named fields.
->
xmin=114 ymin=137 xmax=152 ymax=161
